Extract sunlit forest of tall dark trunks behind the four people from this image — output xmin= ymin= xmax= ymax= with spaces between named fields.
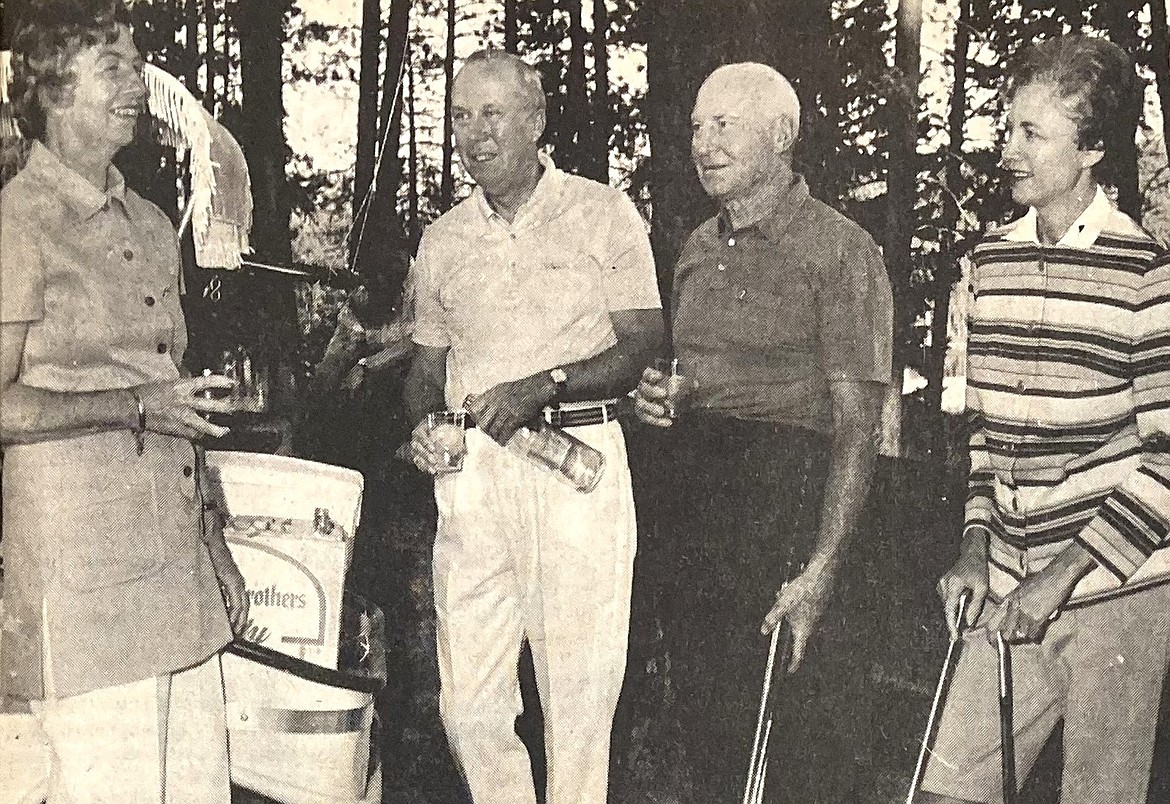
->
xmin=0 ymin=0 xmax=1170 ymax=452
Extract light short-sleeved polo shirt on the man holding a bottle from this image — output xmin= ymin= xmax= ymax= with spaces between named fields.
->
xmin=412 ymin=154 xmax=661 ymax=407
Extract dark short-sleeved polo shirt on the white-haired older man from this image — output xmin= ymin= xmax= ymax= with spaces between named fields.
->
xmin=673 ymin=177 xmax=893 ymax=432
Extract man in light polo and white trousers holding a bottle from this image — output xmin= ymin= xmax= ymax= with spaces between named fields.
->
xmin=406 ymin=50 xmax=662 ymax=804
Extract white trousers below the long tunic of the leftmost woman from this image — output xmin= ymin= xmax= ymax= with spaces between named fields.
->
xmin=20 ymin=654 xmax=230 ymax=804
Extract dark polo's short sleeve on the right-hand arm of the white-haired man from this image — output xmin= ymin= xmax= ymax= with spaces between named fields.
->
xmin=817 ymin=232 xmax=894 ymax=384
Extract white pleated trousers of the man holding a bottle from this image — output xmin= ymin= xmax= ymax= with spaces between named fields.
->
xmin=434 ymin=422 xmax=636 ymax=804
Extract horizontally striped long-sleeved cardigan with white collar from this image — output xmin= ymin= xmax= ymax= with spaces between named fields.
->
xmin=966 ymin=188 xmax=1170 ymax=599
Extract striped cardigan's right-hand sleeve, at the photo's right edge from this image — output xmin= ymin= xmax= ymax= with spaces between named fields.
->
xmin=1078 ymin=255 xmax=1170 ymax=582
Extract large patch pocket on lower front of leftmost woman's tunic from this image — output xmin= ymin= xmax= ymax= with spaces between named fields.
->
xmin=54 ymin=462 xmax=165 ymax=590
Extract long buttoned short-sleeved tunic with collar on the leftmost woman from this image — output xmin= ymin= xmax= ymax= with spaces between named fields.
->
xmin=0 ymin=143 xmax=232 ymax=700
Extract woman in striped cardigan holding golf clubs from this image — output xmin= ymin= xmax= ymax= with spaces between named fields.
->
xmin=923 ymin=36 xmax=1170 ymax=804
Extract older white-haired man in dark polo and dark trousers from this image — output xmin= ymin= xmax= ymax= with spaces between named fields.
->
xmin=636 ymin=63 xmax=892 ymax=804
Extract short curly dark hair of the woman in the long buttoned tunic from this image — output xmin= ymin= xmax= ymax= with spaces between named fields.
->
xmin=5 ymin=0 xmax=132 ymax=139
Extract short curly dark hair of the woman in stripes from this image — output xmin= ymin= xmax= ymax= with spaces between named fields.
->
xmin=1007 ymin=34 xmax=1142 ymax=183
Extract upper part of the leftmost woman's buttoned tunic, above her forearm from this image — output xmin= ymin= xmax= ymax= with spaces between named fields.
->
xmin=0 ymin=143 xmax=187 ymax=391
